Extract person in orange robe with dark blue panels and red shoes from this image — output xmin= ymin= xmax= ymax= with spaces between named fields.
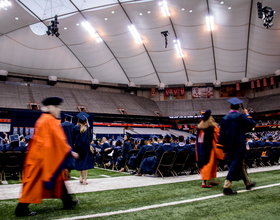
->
xmin=196 ymin=110 xmax=220 ymax=188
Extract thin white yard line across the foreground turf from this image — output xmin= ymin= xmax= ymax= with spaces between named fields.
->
xmin=57 ymin=183 xmax=280 ymax=220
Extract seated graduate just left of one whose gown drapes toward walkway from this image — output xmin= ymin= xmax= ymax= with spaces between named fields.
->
xmin=128 ymin=137 xmax=155 ymax=174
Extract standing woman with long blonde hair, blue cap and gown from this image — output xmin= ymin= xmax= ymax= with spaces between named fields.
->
xmin=74 ymin=112 xmax=94 ymax=185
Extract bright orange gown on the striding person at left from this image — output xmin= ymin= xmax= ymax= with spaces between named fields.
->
xmin=19 ymin=113 xmax=71 ymax=204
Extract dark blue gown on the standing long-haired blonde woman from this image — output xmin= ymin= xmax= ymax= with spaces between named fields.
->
xmin=74 ymin=125 xmax=94 ymax=171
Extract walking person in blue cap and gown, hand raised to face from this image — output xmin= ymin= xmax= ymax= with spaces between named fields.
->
xmin=218 ymin=98 xmax=256 ymax=195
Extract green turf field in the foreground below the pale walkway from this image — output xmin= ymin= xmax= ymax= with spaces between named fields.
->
xmin=0 ymin=169 xmax=280 ymax=220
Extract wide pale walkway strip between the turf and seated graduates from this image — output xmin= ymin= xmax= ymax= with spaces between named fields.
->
xmin=0 ymin=166 xmax=280 ymax=200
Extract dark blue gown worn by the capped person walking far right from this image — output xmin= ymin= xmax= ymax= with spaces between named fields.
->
xmin=219 ymin=112 xmax=256 ymax=181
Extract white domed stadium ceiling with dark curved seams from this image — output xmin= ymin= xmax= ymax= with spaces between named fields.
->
xmin=0 ymin=0 xmax=280 ymax=85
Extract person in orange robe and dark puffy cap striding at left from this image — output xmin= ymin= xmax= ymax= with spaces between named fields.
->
xmin=15 ymin=97 xmax=79 ymax=216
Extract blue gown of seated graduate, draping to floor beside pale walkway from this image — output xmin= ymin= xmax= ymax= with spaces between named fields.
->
xmin=141 ymin=143 xmax=174 ymax=174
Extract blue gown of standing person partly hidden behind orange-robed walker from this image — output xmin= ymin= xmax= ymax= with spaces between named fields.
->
xmin=61 ymin=121 xmax=75 ymax=169
